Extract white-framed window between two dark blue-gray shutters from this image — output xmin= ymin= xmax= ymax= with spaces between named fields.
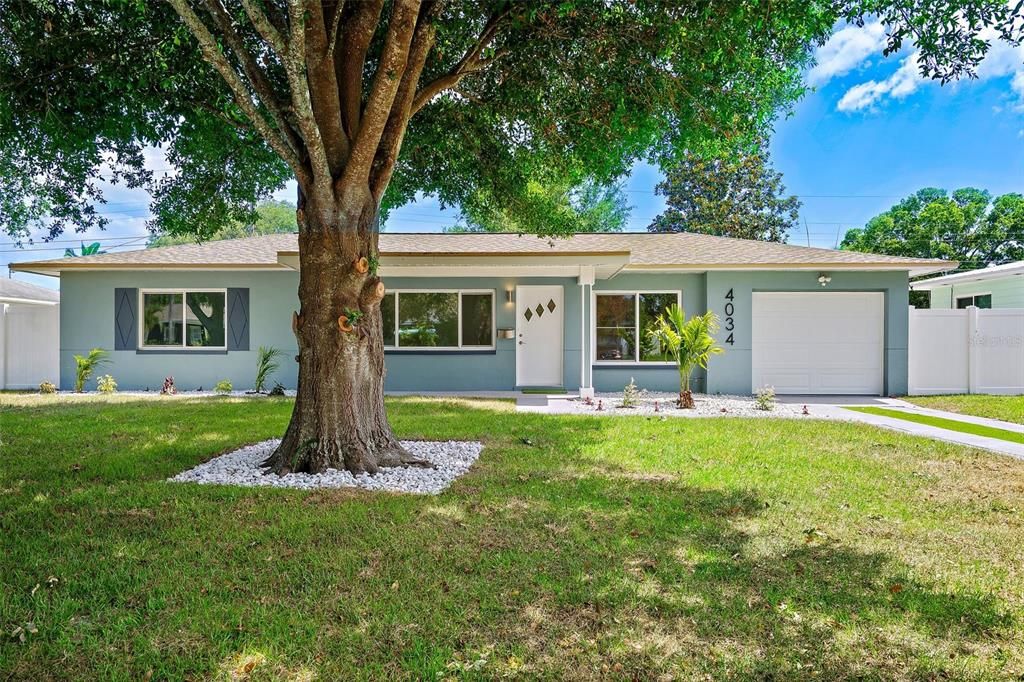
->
xmin=138 ymin=290 xmax=227 ymax=348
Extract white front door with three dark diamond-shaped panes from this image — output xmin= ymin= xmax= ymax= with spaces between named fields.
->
xmin=515 ymin=286 xmax=564 ymax=386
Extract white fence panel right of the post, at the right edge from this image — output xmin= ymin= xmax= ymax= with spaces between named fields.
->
xmin=971 ymin=308 xmax=1024 ymax=395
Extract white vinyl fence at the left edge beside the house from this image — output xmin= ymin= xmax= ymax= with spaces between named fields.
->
xmin=0 ymin=303 xmax=60 ymax=388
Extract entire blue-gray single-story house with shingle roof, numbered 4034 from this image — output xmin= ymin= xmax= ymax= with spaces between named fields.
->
xmin=11 ymin=233 xmax=955 ymax=394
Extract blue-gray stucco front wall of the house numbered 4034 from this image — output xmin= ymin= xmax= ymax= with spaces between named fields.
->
xmin=60 ymin=270 xmax=908 ymax=394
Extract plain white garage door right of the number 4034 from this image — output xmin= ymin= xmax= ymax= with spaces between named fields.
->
xmin=752 ymin=292 xmax=885 ymax=395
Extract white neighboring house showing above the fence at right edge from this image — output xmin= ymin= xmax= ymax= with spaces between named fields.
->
xmin=910 ymin=260 xmax=1024 ymax=308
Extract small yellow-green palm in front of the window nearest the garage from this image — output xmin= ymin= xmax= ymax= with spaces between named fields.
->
xmin=647 ymin=304 xmax=725 ymax=410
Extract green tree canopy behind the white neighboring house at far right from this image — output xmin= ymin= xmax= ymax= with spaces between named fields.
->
xmin=840 ymin=187 xmax=1024 ymax=270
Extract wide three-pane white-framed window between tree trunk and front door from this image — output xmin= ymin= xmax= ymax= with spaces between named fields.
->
xmin=381 ymin=290 xmax=495 ymax=350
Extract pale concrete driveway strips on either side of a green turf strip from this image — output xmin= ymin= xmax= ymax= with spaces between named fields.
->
xmin=808 ymin=398 xmax=1024 ymax=460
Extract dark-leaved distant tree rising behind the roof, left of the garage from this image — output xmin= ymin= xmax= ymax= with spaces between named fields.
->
xmin=647 ymin=141 xmax=800 ymax=242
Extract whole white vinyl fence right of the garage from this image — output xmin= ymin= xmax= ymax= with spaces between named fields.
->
xmin=909 ymin=307 xmax=1024 ymax=395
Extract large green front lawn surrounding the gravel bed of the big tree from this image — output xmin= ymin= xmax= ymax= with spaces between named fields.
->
xmin=0 ymin=395 xmax=1024 ymax=680
